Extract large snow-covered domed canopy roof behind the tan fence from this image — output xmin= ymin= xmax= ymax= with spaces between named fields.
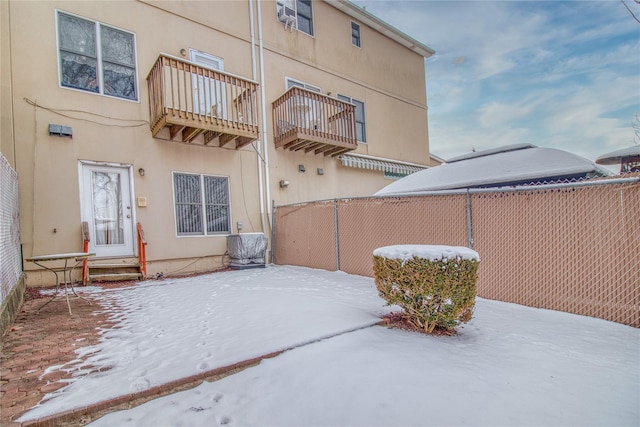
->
xmin=375 ymin=144 xmax=612 ymax=196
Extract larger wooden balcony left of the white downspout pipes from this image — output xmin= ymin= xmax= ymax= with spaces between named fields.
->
xmin=147 ymin=54 xmax=258 ymax=148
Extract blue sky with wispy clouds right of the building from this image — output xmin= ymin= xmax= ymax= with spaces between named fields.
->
xmin=354 ymin=0 xmax=640 ymax=166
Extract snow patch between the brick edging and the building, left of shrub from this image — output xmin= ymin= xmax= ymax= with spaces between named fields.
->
xmin=21 ymin=266 xmax=388 ymax=421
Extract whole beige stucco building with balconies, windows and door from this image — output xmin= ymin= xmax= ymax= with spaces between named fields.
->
xmin=0 ymin=0 xmax=437 ymax=286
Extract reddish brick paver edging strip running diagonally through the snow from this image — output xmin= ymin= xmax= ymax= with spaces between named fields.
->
xmin=8 ymin=350 xmax=287 ymax=427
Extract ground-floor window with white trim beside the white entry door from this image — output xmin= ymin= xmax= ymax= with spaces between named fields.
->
xmin=173 ymin=172 xmax=231 ymax=236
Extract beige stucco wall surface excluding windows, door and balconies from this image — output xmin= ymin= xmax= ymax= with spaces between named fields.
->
xmin=1 ymin=1 xmax=429 ymax=284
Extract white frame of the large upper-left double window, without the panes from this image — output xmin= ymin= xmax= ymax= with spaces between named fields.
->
xmin=55 ymin=9 xmax=140 ymax=102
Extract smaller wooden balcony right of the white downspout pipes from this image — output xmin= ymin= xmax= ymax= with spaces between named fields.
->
xmin=273 ymin=86 xmax=358 ymax=156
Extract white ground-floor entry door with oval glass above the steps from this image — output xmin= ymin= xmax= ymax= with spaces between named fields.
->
xmin=80 ymin=163 xmax=135 ymax=257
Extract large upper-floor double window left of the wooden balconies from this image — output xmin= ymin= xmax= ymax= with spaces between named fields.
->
xmin=57 ymin=11 xmax=138 ymax=101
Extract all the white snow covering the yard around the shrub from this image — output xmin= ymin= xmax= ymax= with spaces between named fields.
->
xmin=17 ymin=266 xmax=640 ymax=426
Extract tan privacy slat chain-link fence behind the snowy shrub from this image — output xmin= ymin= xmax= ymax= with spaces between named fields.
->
xmin=273 ymin=175 xmax=640 ymax=327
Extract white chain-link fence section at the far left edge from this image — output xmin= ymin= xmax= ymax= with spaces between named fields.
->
xmin=0 ymin=153 xmax=22 ymax=304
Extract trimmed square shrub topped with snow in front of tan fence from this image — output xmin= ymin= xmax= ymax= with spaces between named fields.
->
xmin=373 ymin=245 xmax=480 ymax=333
